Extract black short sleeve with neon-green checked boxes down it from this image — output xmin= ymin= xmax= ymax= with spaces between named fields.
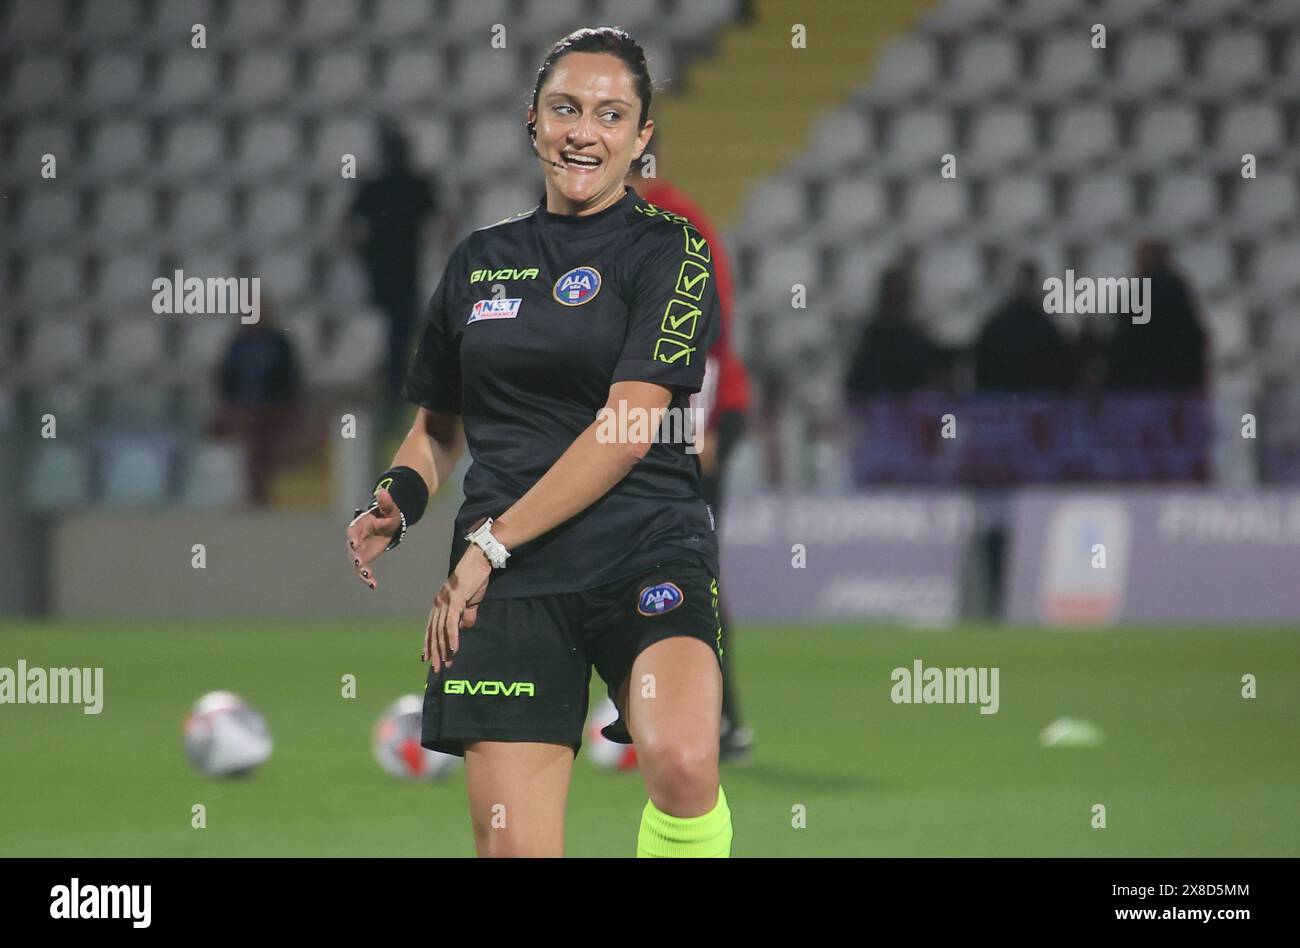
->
xmin=611 ymin=218 xmax=722 ymax=394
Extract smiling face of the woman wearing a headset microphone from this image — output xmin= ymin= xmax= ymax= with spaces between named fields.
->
xmin=528 ymin=52 xmax=654 ymax=216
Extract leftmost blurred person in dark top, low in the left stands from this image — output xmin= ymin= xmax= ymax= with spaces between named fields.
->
xmin=212 ymin=300 xmax=302 ymax=506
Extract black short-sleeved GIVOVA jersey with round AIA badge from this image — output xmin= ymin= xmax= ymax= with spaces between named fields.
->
xmin=404 ymin=187 xmax=720 ymax=598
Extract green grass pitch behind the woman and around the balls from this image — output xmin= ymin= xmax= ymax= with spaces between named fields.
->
xmin=0 ymin=622 xmax=1300 ymax=857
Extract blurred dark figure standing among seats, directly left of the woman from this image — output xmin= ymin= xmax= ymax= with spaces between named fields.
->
xmin=347 ymin=121 xmax=438 ymax=404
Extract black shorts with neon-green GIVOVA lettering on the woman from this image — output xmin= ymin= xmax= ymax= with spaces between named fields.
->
xmin=421 ymin=555 xmax=722 ymax=757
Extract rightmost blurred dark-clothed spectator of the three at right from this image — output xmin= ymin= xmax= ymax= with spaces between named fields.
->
xmin=1109 ymin=241 xmax=1208 ymax=394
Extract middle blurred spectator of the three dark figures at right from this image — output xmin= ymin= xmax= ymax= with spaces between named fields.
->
xmin=975 ymin=260 xmax=1073 ymax=391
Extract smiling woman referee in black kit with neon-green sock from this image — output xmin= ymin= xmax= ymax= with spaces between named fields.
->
xmin=347 ymin=27 xmax=732 ymax=857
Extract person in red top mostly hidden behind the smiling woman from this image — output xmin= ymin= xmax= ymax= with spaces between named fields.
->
xmin=627 ymin=151 xmax=754 ymax=762
